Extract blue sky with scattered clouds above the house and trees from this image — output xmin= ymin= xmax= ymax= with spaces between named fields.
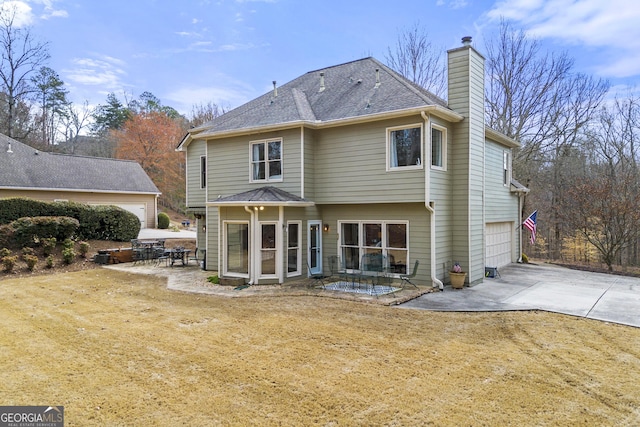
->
xmin=3 ymin=0 xmax=640 ymax=114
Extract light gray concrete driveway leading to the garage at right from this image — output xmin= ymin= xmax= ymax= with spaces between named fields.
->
xmin=399 ymin=264 xmax=640 ymax=327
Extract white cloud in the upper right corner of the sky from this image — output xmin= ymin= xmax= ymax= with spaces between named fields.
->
xmin=487 ymin=0 xmax=640 ymax=77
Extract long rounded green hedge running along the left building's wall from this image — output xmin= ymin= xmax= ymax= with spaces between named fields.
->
xmin=0 ymin=198 xmax=140 ymax=242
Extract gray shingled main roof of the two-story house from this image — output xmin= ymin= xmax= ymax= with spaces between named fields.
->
xmin=194 ymin=58 xmax=449 ymax=133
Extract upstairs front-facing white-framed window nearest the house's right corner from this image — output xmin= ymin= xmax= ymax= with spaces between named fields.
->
xmin=387 ymin=125 xmax=422 ymax=170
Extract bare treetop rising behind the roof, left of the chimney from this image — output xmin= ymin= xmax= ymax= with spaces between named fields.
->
xmin=385 ymin=22 xmax=447 ymax=99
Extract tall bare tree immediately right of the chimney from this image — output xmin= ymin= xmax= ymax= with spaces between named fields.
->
xmin=485 ymin=21 xmax=609 ymax=257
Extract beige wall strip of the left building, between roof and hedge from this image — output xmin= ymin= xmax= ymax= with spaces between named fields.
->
xmin=0 ymin=190 xmax=157 ymax=228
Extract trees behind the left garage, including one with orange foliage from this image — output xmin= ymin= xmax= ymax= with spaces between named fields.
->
xmin=0 ymin=7 xmax=224 ymax=211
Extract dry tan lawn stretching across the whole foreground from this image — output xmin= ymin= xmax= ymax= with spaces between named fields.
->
xmin=0 ymin=269 xmax=640 ymax=426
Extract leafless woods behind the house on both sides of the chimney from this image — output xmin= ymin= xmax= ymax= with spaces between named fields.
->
xmin=387 ymin=21 xmax=640 ymax=270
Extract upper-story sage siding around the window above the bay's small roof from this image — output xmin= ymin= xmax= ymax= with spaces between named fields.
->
xmin=207 ymin=128 xmax=301 ymax=201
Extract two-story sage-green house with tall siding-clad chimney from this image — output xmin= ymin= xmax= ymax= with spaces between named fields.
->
xmin=178 ymin=37 xmax=526 ymax=287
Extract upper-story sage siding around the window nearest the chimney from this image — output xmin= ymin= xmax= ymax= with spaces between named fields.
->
xmin=315 ymin=115 xmax=425 ymax=204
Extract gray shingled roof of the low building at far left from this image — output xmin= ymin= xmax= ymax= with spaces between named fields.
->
xmin=0 ymin=134 xmax=160 ymax=193
